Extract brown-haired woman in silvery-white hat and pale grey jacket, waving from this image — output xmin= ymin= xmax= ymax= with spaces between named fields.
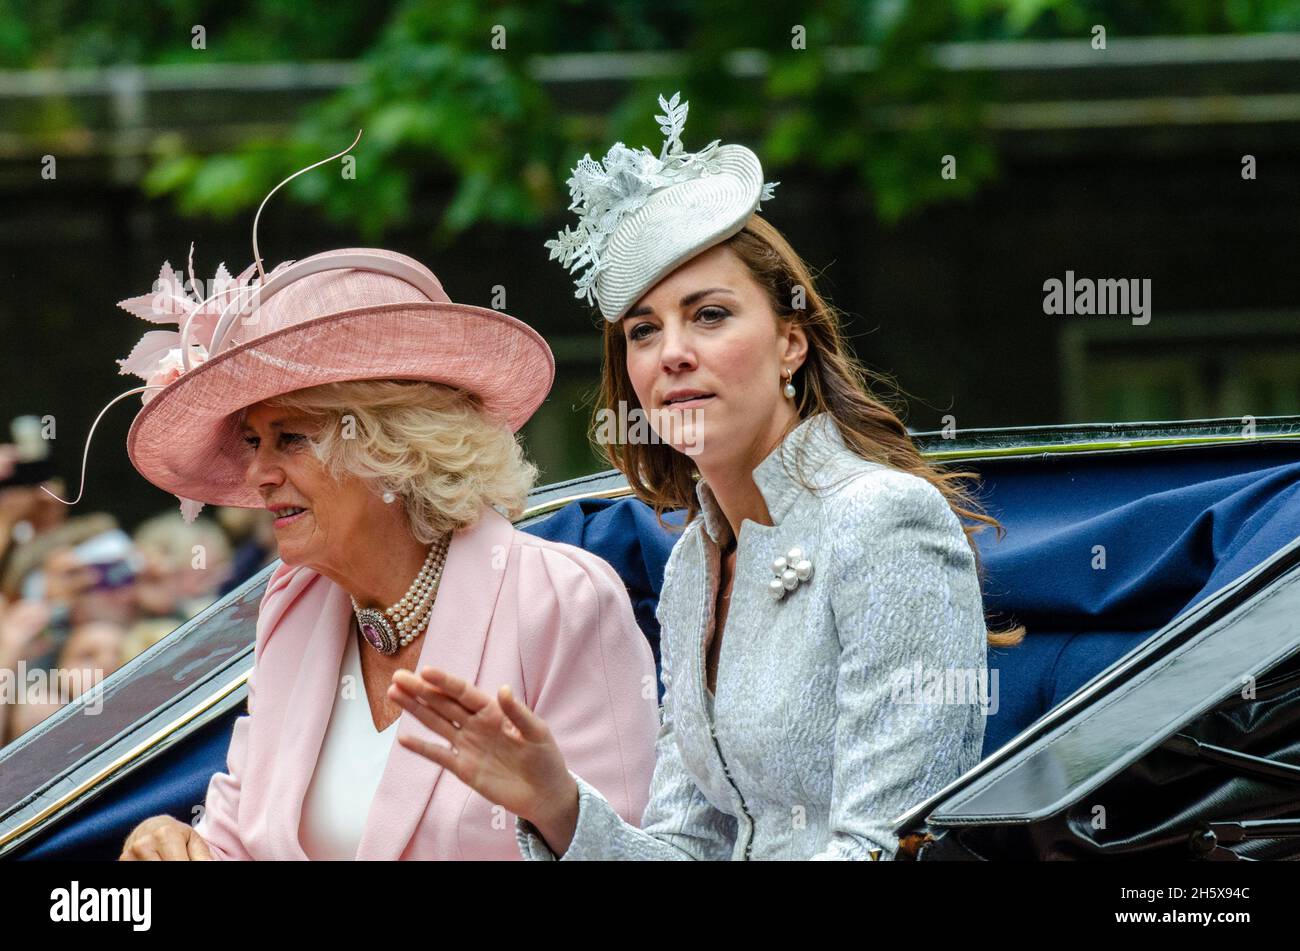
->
xmin=394 ymin=96 xmax=1023 ymax=859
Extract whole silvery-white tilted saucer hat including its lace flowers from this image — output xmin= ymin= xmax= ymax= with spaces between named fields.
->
xmin=546 ymin=92 xmax=780 ymax=323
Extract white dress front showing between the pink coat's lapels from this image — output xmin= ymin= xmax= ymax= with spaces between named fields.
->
xmin=298 ymin=625 xmax=399 ymax=861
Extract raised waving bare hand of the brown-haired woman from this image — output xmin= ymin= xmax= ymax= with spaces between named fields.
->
xmin=389 ymin=666 xmax=577 ymax=854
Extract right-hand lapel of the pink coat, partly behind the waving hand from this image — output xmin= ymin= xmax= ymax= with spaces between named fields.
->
xmin=358 ymin=507 xmax=515 ymax=860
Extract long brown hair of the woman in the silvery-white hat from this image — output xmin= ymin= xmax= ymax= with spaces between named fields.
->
xmin=592 ymin=213 xmax=1024 ymax=647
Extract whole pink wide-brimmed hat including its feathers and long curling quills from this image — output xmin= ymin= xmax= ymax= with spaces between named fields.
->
xmin=46 ymin=134 xmax=555 ymax=521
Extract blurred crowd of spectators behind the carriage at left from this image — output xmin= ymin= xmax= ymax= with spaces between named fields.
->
xmin=0 ymin=417 xmax=276 ymax=746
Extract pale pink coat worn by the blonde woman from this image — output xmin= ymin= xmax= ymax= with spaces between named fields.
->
xmin=196 ymin=508 xmax=659 ymax=860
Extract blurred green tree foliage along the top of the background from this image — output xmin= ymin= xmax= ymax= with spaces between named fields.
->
xmin=0 ymin=0 xmax=1300 ymax=240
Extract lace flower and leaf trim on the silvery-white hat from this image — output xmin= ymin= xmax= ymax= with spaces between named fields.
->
xmin=545 ymin=91 xmax=780 ymax=304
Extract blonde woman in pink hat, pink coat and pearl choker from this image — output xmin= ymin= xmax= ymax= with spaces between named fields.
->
xmin=43 ymin=143 xmax=658 ymax=860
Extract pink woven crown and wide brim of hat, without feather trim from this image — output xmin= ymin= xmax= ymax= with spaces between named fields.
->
xmin=126 ymin=248 xmax=555 ymax=508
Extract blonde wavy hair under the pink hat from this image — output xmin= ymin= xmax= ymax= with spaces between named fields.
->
xmin=239 ymin=379 xmax=537 ymax=544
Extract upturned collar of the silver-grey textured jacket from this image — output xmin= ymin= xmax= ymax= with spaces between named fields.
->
xmin=696 ymin=413 xmax=852 ymax=544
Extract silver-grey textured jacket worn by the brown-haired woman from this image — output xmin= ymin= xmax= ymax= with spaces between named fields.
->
xmin=516 ymin=413 xmax=989 ymax=860
